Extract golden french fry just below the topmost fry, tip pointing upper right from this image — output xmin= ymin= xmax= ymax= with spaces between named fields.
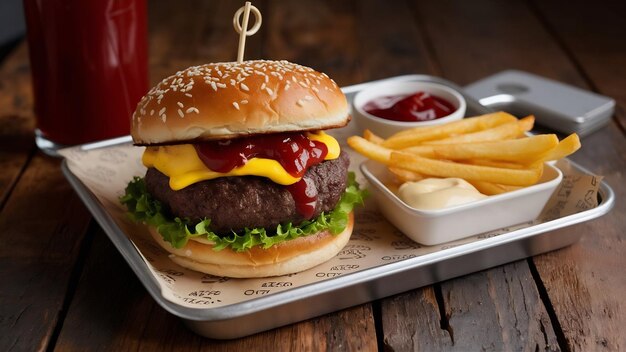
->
xmin=424 ymin=116 xmax=535 ymax=144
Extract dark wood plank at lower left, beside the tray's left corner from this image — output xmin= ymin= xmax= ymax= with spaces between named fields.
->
xmin=0 ymin=154 xmax=90 ymax=351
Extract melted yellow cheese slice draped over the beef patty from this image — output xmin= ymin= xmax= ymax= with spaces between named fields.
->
xmin=142 ymin=131 xmax=340 ymax=191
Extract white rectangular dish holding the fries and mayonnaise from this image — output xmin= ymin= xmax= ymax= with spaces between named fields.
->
xmin=361 ymin=160 xmax=563 ymax=246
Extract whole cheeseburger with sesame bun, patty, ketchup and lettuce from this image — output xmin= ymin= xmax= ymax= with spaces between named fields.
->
xmin=120 ymin=60 xmax=362 ymax=277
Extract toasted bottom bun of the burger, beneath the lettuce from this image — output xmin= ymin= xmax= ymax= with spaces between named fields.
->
xmin=150 ymin=213 xmax=354 ymax=278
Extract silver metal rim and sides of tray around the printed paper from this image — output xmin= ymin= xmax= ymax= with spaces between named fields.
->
xmin=62 ymin=75 xmax=615 ymax=339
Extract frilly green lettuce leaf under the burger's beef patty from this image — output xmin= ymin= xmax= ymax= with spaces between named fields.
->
xmin=120 ymin=172 xmax=366 ymax=252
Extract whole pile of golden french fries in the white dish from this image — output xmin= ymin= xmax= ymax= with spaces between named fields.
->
xmin=348 ymin=113 xmax=580 ymax=195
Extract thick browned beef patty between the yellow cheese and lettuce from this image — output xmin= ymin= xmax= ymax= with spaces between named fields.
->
xmin=145 ymin=152 xmax=350 ymax=234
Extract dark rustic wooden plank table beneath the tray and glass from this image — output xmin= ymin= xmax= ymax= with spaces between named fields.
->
xmin=0 ymin=0 xmax=626 ymax=351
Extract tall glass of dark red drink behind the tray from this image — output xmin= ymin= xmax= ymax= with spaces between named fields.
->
xmin=24 ymin=0 xmax=148 ymax=153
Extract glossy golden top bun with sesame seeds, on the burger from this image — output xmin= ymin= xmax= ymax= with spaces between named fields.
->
xmin=131 ymin=60 xmax=350 ymax=145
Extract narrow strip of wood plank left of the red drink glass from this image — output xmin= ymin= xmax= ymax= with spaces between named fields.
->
xmin=0 ymin=43 xmax=35 ymax=209
